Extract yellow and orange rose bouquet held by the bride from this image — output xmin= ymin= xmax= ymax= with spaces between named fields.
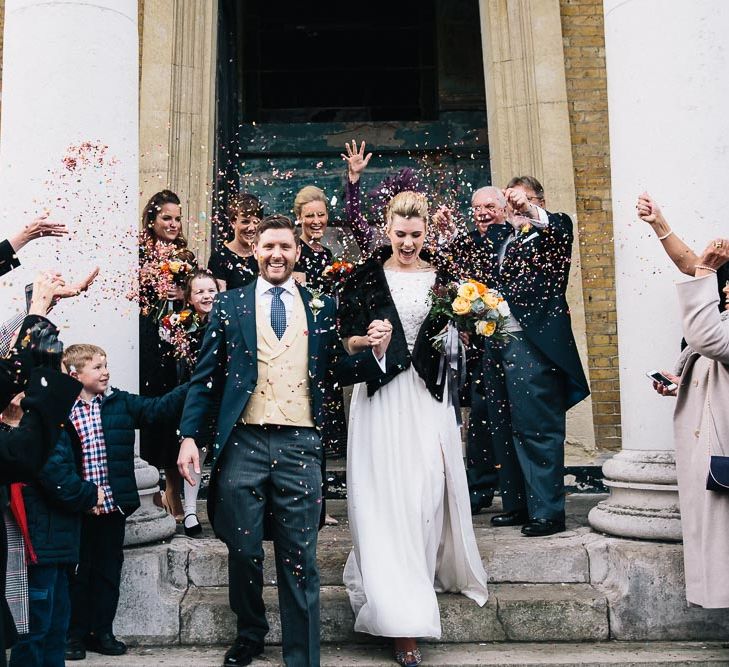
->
xmin=430 ymin=280 xmax=511 ymax=352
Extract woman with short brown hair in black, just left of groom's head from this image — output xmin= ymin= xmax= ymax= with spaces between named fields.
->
xmin=208 ymin=192 xmax=263 ymax=291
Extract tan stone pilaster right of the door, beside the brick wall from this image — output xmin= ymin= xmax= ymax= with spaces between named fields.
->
xmin=479 ymin=0 xmax=596 ymax=464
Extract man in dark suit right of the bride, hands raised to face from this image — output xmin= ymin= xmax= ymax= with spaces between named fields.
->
xmin=481 ymin=177 xmax=590 ymax=536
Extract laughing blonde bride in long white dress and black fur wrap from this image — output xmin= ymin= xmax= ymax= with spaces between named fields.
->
xmin=339 ymin=192 xmax=488 ymax=666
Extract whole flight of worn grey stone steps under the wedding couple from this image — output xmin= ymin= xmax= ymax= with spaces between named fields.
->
xmin=109 ymin=494 xmax=729 ymax=665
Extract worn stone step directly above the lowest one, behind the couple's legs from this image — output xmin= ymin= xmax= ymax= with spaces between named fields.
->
xmin=180 ymin=584 xmax=609 ymax=646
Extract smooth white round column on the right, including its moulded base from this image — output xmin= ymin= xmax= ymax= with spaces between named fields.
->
xmin=590 ymin=0 xmax=729 ymax=540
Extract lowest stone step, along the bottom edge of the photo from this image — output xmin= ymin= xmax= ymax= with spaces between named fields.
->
xmin=75 ymin=641 xmax=729 ymax=667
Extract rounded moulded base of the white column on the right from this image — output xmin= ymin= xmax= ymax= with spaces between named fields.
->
xmin=588 ymin=449 xmax=682 ymax=542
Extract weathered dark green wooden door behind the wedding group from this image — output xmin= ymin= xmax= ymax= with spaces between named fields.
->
xmin=216 ymin=0 xmax=491 ymax=258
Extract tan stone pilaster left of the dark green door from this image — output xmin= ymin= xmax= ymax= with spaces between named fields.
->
xmin=139 ymin=0 xmax=218 ymax=266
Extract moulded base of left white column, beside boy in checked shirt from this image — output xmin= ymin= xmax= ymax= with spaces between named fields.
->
xmin=124 ymin=456 xmax=177 ymax=547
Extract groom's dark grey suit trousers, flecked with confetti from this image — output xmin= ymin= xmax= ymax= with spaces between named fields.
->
xmin=214 ymin=424 xmax=323 ymax=667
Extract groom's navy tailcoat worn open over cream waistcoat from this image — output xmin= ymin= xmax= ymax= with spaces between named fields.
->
xmin=180 ymin=281 xmax=382 ymax=474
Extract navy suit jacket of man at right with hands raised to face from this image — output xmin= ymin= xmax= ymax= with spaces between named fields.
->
xmin=497 ymin=213 xmax=590 ymax=408
